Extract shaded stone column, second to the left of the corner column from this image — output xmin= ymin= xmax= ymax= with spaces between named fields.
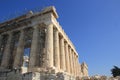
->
xmin=13 ymin=30 xmax=24 ymax=68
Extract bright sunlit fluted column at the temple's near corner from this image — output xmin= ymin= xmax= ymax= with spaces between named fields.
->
xmin=45 ymin=24 xmax=53 ymax=68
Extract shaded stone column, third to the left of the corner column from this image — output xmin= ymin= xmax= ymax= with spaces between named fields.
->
xmin=1 ymin=33 xmax=12 ymax=68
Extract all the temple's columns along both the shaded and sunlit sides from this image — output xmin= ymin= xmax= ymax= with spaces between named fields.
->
xmin=0 ymin=24 xmax=79 ymax=76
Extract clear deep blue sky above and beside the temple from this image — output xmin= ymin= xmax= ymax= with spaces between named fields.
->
xmin=0 ymin=0 xmax=120 ymax=75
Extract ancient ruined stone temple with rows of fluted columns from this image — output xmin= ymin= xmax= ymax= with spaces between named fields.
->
xmin=0 ymin=6 xmax=88 ymax=80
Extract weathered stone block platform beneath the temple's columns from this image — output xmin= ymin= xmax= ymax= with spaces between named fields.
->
xmin=0 ymin=69 xmax=80 ymax=80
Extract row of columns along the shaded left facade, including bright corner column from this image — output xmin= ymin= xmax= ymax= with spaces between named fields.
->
xmin=0 ymin=24 xmax=53 ymax=69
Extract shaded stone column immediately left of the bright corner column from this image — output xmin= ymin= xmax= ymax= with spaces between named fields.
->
xmin=29 ymin=26 xmax=39 ymax=69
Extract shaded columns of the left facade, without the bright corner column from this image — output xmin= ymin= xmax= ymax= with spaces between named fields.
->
xmin=0 ymin=27 xmax=39 ymax=69
